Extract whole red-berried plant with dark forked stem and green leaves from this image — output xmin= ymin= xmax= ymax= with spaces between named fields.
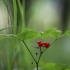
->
xmin=0 ymin=28 xmax=70 ymax=70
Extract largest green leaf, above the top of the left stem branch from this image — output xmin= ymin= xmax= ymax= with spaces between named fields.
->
xmin=17 ymin=28 xmax=40 ymax=40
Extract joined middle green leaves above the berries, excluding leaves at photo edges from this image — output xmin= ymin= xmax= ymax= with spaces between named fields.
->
xmin=17 ymin=28 xmax=62 ymax=40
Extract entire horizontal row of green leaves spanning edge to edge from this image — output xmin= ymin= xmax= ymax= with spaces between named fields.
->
xmin=0 ymin=28 xmax=70 ymax=40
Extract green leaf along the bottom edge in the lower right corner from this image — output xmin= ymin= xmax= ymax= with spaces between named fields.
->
xmin=43 ymin=63 xmax=70 ymax=70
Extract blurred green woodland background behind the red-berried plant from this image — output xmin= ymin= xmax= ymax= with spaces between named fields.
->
xmin=0 ymin=0 xmax=70 ymax=70
